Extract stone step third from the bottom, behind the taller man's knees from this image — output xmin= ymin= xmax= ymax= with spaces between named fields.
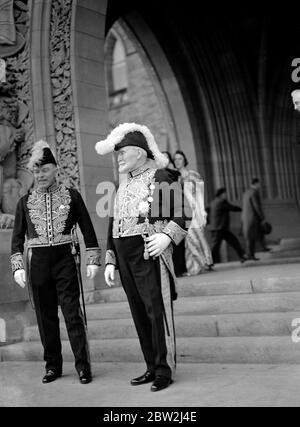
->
xmin=74 ymin=292 xmax=300 ymax=320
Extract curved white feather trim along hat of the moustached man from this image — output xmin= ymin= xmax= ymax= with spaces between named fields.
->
xmin=95 ymin=123 xmax=168 ymax=169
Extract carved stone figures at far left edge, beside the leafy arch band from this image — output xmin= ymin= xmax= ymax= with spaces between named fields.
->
xmin=0 ymin=0 xmax=33 ymax=228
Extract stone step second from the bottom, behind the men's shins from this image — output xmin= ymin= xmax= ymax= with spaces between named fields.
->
xmin=24 ymin=310 xmax=300 ymax=341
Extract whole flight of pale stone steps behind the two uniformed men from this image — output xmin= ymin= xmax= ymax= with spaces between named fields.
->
xmin=0 ymin=263 xmax=300 ymax=364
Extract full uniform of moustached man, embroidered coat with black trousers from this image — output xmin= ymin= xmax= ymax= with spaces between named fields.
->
xmin=105 ymin=164 xmax=189 ymax=377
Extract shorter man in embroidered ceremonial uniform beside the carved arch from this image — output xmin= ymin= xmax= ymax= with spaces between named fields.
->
xmin=11 ymin=141 xmax=100 ymax=384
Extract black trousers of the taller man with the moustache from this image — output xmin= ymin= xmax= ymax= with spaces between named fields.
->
xmin=114 ymin=236 xmax=173 ymax=378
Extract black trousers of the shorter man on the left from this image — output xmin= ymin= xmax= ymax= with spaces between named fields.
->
xmin=30 ymin=245 xmax=90 ymax=372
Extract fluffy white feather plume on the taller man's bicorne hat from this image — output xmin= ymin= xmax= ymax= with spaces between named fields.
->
xmin=95 ymin=123 xmax=168 ymax=168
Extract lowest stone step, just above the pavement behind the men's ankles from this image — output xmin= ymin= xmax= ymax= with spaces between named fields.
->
xmin=0 ymin=336 xmax=300 ymax=364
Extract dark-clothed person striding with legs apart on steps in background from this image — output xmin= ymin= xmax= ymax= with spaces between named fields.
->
xmin=207 ymin=188 xmax=247 ymax=263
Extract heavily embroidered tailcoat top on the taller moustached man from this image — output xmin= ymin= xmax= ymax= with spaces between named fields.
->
xmin=105 ymin=165 xmax=187 ymax=265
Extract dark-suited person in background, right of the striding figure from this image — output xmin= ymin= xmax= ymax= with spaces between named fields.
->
xmin=242 ymin=178 xmax=265 ymax=261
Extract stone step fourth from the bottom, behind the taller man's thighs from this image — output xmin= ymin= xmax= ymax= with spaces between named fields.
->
xmin=97 ymin=275 xmax=300 ymax=302
